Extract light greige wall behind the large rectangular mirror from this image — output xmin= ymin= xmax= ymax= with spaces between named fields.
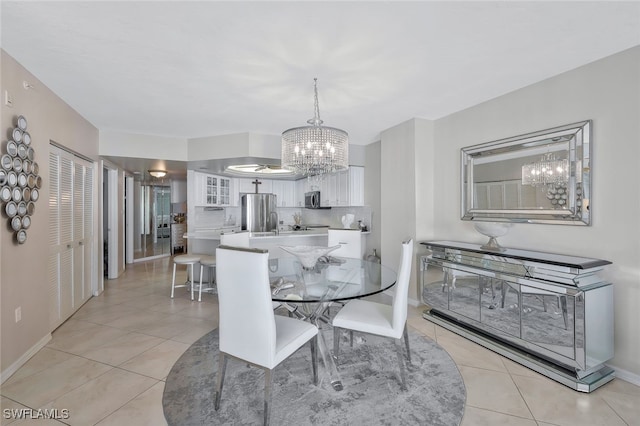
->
xmin=424 ymin=47 xmax=640 ymax=380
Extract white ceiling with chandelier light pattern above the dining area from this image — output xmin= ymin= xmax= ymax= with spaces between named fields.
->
xmin=1 ymin=0 xmax=640 ymax=170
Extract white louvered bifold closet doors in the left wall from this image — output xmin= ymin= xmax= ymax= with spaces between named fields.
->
xmin=49 ymin=146 xmax=94 ymax=330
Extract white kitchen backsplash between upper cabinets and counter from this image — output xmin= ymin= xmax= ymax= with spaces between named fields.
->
xmin=187 ymin=207 xmax=371 ymax=230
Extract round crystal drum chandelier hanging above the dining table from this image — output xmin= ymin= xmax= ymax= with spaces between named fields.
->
xmin=281 ymin=78 xmax=349 ymax=176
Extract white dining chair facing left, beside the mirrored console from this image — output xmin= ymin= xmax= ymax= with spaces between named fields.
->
xmin=332 ymin=239 xmax=413 ymax=390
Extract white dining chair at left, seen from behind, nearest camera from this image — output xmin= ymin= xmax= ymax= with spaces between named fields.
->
xmin=215 ymin=246 xmax=318 ymax=425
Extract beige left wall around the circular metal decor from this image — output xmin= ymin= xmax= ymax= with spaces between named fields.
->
xmin=0 ymin=51 xmax=99 ymax=380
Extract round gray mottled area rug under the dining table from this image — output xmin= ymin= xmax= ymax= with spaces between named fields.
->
xmin=162 ymin=327 xmax=466 ymax=426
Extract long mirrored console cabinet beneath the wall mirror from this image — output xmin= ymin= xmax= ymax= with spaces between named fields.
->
xmin=420 ymin=241 xmax=614 ymax=392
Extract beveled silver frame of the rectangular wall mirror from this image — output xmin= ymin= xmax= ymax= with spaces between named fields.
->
xmin=460 ymin=120 xmax=592 ymax=225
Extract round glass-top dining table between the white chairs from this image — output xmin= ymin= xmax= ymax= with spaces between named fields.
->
xmin=269 ymin=257 xmax=396 ymax=391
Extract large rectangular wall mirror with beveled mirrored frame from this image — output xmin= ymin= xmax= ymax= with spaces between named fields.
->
xmin=461 ymin=120 xmax=591 ymax=225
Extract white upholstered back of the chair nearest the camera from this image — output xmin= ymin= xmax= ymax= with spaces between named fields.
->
xmin=216 ymin=246 xmax=276 ymax=369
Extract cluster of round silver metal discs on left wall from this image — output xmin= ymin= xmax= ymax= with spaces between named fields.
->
xmin=0 ymin=115 xmax=42 ymax=244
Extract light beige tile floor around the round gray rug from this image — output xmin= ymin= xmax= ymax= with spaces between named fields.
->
xmin=0 ymin=258 xmax=640 ymax=426
